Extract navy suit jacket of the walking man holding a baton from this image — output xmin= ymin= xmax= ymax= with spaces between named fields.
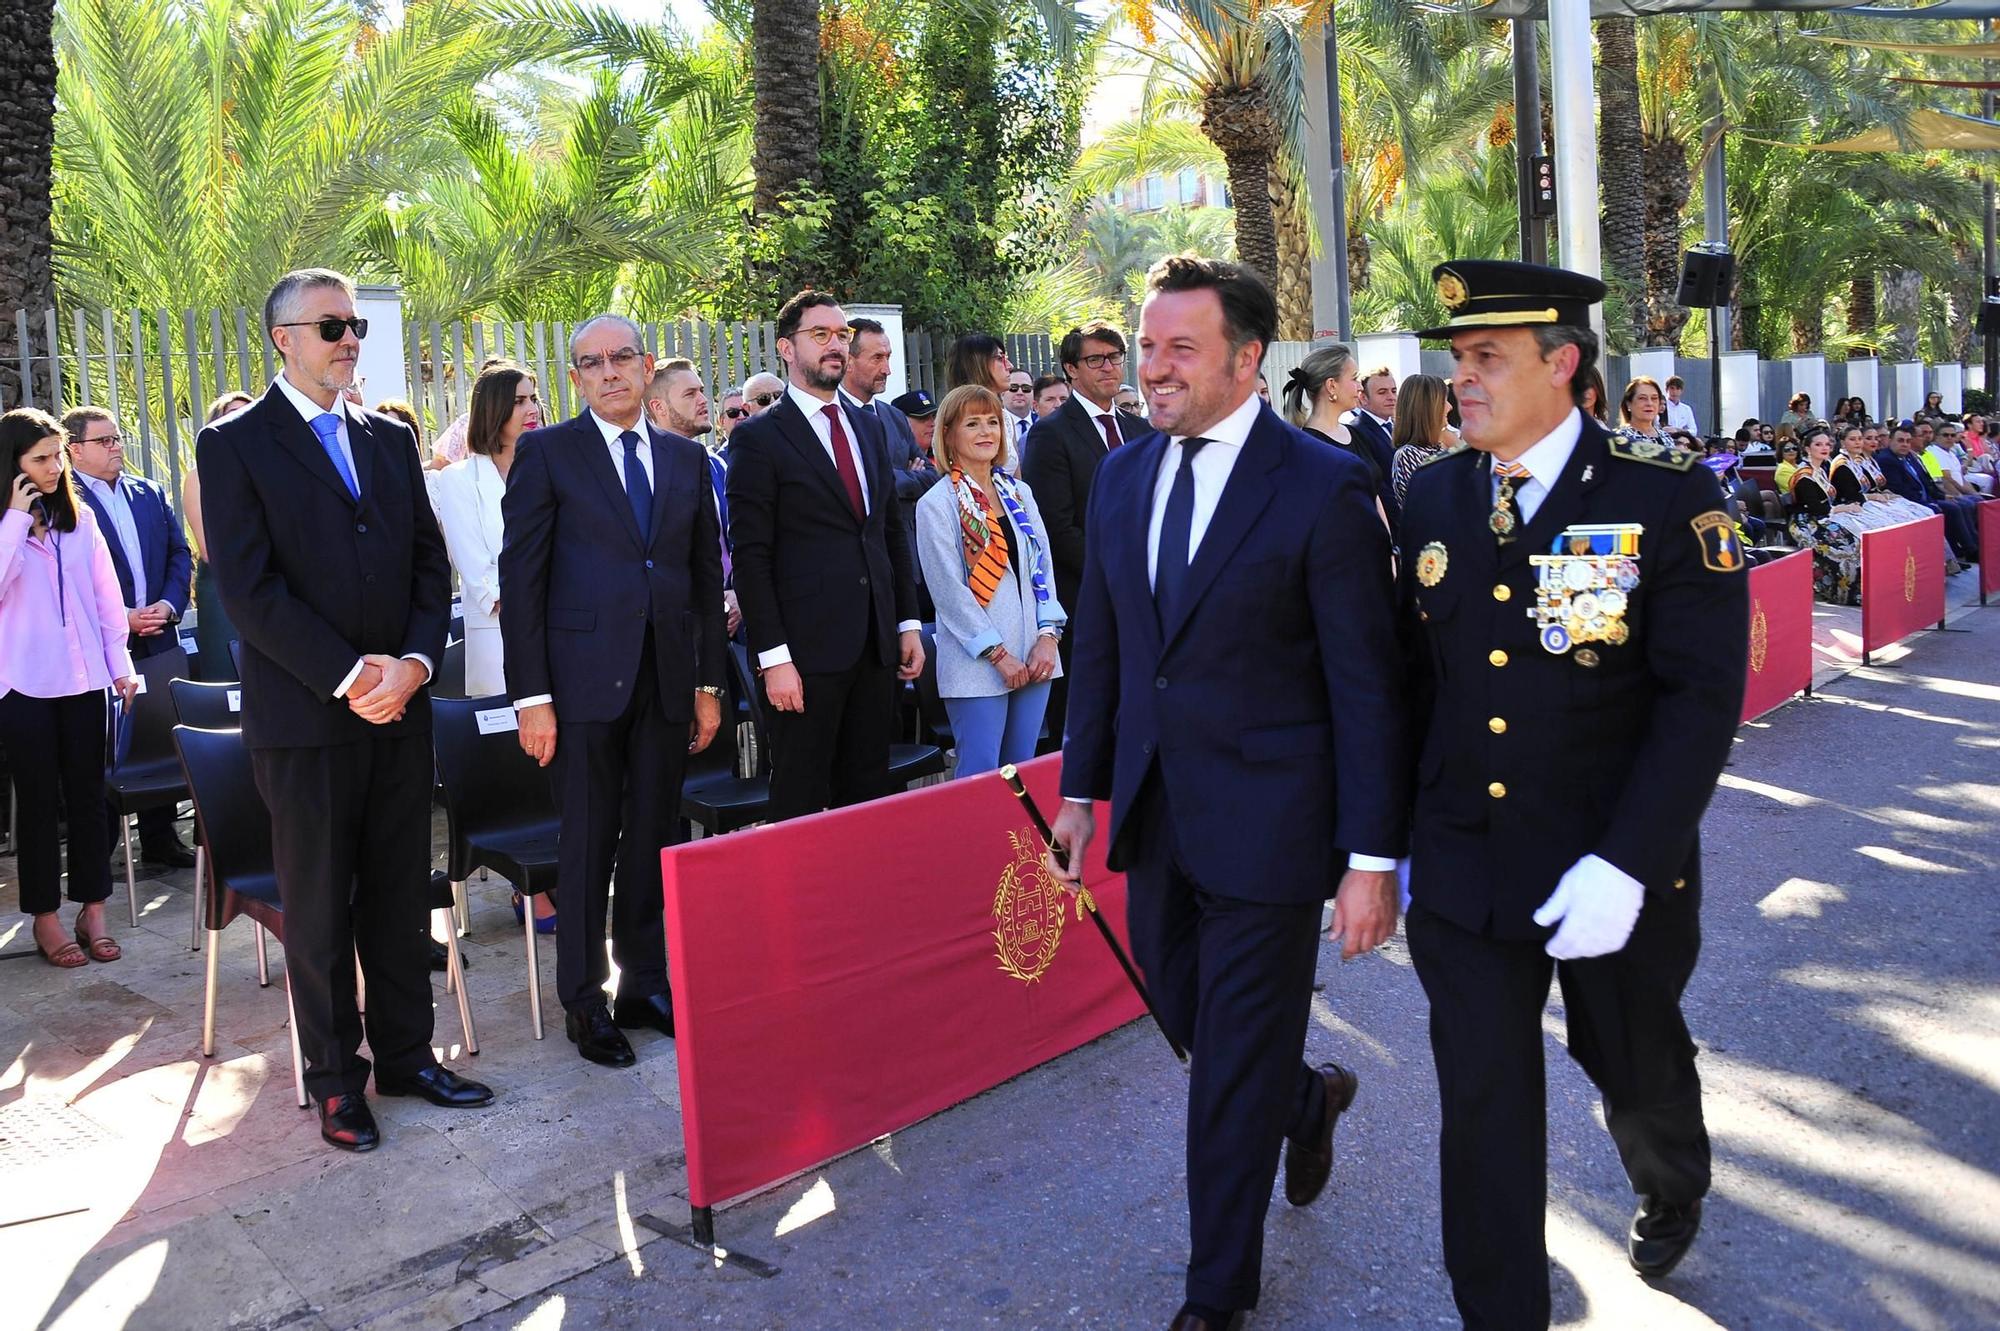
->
xmin=1062 ymin=406 xmax=1410 ymax=903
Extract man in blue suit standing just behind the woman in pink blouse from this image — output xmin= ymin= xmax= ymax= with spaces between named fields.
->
xmin=62 ymin=408 xmax=194 ymax=869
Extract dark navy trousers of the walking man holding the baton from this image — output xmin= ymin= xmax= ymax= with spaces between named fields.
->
xmin=1126 ymin=779 xmax=1326 ymax=1311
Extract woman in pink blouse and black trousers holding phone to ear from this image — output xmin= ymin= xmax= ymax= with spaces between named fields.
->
xmin=0 ymin=410 xmax=138 ymax=969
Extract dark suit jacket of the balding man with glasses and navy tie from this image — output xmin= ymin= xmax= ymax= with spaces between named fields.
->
xmin=500 ymin=412 xmax=728 ymax=721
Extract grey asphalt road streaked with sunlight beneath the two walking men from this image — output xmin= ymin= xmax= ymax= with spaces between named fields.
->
xmin=472 ymin=610 xmax=2000 ymax=1331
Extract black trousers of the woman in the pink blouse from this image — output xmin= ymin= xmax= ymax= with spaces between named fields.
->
xmin=0 ymin=689 xmax=112 ymax=915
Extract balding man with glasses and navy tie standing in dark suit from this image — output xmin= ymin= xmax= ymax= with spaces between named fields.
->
xmin=500 ymin=314 xmax=728 ymax=1067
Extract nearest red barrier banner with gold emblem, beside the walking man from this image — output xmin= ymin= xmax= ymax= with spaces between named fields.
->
xmin=662 ymin=753 xmax=1146 ymax=1207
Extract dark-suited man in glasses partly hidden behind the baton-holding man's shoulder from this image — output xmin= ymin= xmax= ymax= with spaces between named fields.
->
xmin=1020 ymin=315 xmax=1146 ymax=749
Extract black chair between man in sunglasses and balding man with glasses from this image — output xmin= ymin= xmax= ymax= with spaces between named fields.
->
xmin=430 ymin=693 xmax=560 ymax=1039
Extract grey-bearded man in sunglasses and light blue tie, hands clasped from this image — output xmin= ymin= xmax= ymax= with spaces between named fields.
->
xmin=196 ymin=268 xmax=492 ymax=1151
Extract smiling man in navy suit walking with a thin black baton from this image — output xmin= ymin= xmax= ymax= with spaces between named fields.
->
xmin=1050 ymin=256 xmax=1408 ymax=1331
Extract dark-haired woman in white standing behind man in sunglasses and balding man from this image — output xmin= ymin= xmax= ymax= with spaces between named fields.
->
xmin=436 ymin=362 xmax=542 ymax=697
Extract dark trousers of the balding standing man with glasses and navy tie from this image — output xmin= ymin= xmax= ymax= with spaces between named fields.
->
xmin=554 ymin=634 xmax=688 ymax=1007
